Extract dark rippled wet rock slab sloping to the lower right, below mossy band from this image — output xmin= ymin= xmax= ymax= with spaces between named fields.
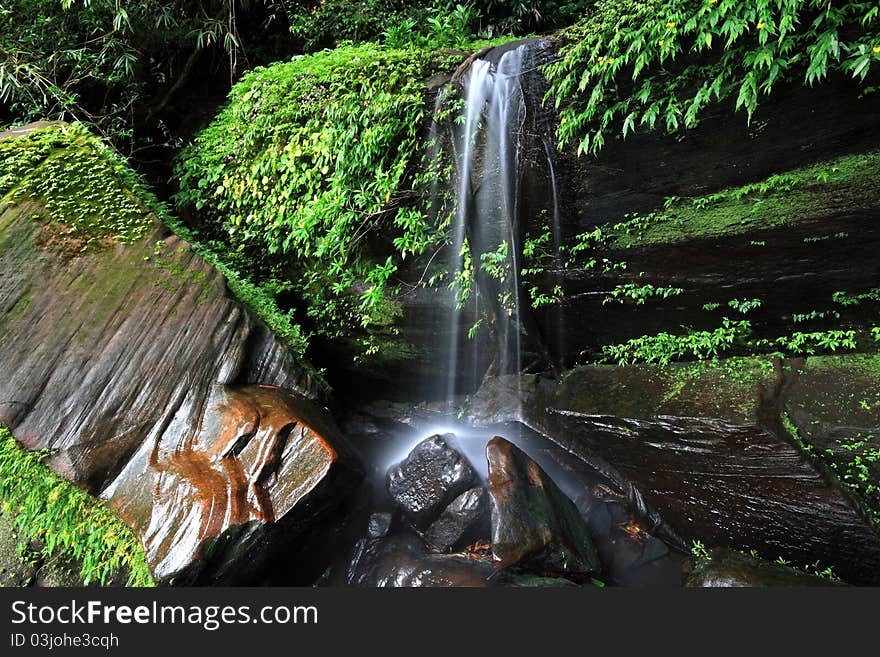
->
xmin=548 ymin=404 xmax=880 ymax=584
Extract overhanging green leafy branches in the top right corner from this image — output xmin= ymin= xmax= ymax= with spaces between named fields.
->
xmin=546 ymin=0 xmax=880 ymax=153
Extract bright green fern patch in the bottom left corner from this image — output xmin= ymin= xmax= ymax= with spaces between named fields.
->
xmin=0 ymin=427 xmax=153 ymax=586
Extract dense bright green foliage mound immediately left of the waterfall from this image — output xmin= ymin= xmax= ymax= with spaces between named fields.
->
xmin=176 ymin=45 xmax=460 ymax=344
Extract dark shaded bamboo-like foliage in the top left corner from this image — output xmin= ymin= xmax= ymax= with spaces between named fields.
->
xmin=0 ymin=0 xmax=296 ymax=146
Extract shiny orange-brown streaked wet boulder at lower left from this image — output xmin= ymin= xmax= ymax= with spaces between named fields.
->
xmin=103 ymin=386 xmax=355 ymax=583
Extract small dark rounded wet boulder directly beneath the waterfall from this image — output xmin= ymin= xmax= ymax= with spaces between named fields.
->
xmin=385 ymin=434 xmax=475 ymax=527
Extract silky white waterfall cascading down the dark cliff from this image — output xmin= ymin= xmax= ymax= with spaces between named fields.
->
xmin=446 ymin=41 xmax=561 ymax=401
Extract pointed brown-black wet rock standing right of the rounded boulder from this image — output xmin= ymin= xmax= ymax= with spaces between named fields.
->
xmin=486 ymin=436 xmax=601 ymax=575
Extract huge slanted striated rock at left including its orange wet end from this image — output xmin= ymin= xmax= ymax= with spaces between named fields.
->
xmin=0 ymin=124 xmax=356 ymax=583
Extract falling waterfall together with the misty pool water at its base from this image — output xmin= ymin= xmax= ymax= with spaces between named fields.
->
xmin=310 ymin=40 xmax=680 ymax=585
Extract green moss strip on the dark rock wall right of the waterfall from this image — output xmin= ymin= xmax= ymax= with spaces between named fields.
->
xmin=609 ymin=153 xmax=880 ymax=249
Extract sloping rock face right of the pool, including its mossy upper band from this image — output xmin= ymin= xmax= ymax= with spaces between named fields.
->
xmin=472 ymin=366 xmax=880 ymax=584
